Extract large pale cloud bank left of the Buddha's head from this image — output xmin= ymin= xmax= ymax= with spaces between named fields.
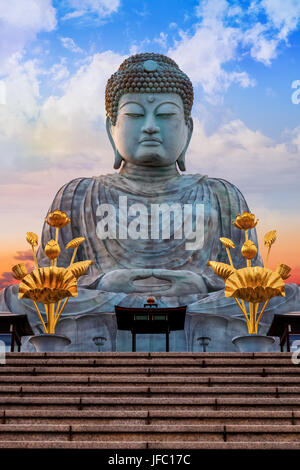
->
xmin=0 ymin=51 xmax=124 ymax=178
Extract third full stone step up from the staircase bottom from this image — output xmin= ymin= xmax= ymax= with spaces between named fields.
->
xmin=0 ymin=395 xmax=300 ymax=412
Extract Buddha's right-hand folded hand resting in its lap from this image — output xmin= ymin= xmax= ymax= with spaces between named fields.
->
xmin=152 ymin=269 xmax=207 ymax=296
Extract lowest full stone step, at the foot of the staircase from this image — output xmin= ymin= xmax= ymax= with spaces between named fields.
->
xmin=0 ymin=424 xmax=300 ymax=445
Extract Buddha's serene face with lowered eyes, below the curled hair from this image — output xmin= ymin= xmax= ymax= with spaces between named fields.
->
xmin=110 ymin=93 xmax=191 ymax=166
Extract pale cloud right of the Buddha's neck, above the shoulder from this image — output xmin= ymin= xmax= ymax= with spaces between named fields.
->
xmin=186 ymin=118 xmax=300 ymax=198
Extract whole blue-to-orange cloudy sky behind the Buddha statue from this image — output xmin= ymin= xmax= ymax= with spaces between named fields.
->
xmin=0 ymin=0 xmax=300 ymax=288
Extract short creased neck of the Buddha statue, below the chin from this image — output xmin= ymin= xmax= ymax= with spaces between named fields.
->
xmin=119 ymin=162 xmax=180 ymax=178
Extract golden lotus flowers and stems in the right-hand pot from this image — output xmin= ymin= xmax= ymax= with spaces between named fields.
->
xmin=207 ymin=212 xmax=291 ymax=334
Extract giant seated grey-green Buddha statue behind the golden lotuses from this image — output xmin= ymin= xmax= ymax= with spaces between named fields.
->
xmin=0 ymin=53 xmax=300 ymax=351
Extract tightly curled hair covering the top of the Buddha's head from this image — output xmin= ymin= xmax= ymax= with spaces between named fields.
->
xmin=105 ymin=52 xmax=194 ymax=125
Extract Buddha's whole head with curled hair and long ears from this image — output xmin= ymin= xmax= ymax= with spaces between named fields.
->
xmin=105 ymin=53 xmax=193 ymax=171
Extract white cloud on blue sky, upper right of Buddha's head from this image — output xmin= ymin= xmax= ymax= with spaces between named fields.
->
xmin=168 ymin=0 xmax=300 ymax=104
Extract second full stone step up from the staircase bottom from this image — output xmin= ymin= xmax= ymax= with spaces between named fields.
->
xmin=0 ymin=408 xmax=300 ymax=425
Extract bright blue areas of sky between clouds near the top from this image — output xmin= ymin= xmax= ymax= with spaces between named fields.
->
xmin=15 ymin=0 xmax=300 ymax=140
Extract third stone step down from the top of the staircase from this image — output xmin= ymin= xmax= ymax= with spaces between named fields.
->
xmin=0 ymin=373 xmax=300 ymax=387
